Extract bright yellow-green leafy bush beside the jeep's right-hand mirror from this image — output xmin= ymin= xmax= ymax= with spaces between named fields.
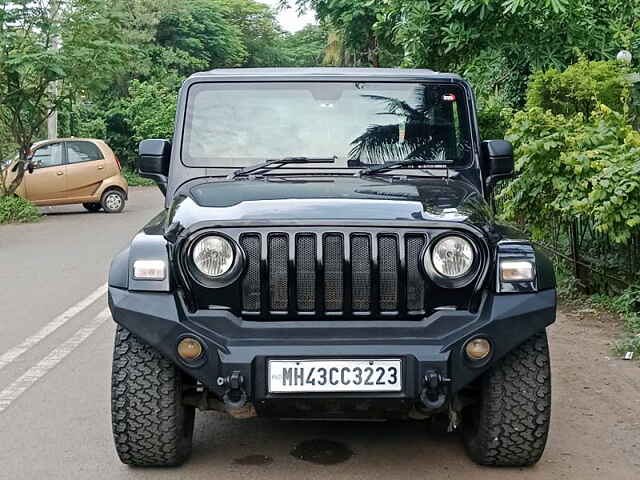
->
xmin=500 ymin=105 xmax=640 ymax=243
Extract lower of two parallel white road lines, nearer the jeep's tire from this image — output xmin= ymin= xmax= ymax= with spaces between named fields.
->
xmin=0 ymin=308 xmax=109 ymax=413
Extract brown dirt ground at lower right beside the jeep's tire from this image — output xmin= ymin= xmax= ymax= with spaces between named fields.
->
xmin=545 ymin=304 xmax=640 ymax=479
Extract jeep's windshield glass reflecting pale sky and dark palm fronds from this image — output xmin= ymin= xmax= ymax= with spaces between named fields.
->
xmin=182 ymin=82 xmax=471 ymax=169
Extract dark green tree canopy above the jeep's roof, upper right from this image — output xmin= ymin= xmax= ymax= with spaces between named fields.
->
xmin=296 ymin=0 xmax=640 ymax=100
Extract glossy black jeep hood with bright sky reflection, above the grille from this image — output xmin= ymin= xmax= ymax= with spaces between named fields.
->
xmin=167 ymin=176 xmax=493 ymax=229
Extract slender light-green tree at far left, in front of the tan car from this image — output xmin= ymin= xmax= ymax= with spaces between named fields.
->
xmin=0 ymin=0 xmax=127 ymax=195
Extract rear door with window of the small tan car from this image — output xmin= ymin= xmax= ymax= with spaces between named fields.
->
xmin=65 ymin=140 xmax=106 ymax=202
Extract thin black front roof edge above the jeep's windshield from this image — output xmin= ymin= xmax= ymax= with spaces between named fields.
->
xmin=190 ymin=67 xmax=462 ymax=81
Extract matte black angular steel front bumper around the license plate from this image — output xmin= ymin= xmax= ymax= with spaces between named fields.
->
xmin=109 ymin=287 xmax=556 ymax=412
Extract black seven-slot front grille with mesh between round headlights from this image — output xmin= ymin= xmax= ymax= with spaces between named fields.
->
xmin=240 ymin=231 xmax=427 ymax=318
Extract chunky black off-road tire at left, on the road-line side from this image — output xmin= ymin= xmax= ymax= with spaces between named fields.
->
xmin=111 ymin=327 xmax=195 ymax=467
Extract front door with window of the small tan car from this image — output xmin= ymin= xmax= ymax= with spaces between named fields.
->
xmin=23 ymin=142 xmax=67 ymax=205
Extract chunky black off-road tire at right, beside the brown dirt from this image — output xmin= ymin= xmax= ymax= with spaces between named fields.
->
xmin=462 ymin=331 xmax=551 ymax=467
